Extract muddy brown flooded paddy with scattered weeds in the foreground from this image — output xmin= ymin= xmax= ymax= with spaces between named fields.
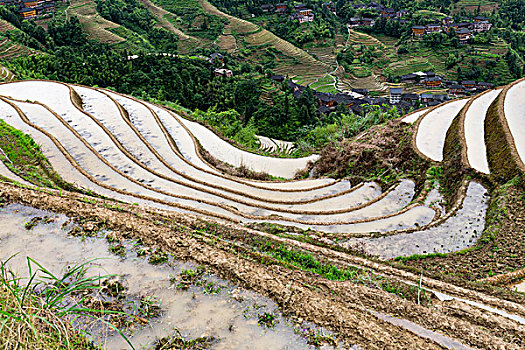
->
xmin=0 ymin=204 xmax=331 ymax=349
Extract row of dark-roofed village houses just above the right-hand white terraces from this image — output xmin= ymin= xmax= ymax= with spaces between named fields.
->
xmin=400 ymin=71 xmax=494 ymax=96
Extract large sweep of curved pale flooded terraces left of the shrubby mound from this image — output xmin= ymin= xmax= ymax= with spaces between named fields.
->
xmin=0 ymin=81 xmax=478 ymax=245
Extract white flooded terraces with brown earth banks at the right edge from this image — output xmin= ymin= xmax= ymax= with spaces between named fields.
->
xmin=403 ymin=79 xmax=525 ymax=178
